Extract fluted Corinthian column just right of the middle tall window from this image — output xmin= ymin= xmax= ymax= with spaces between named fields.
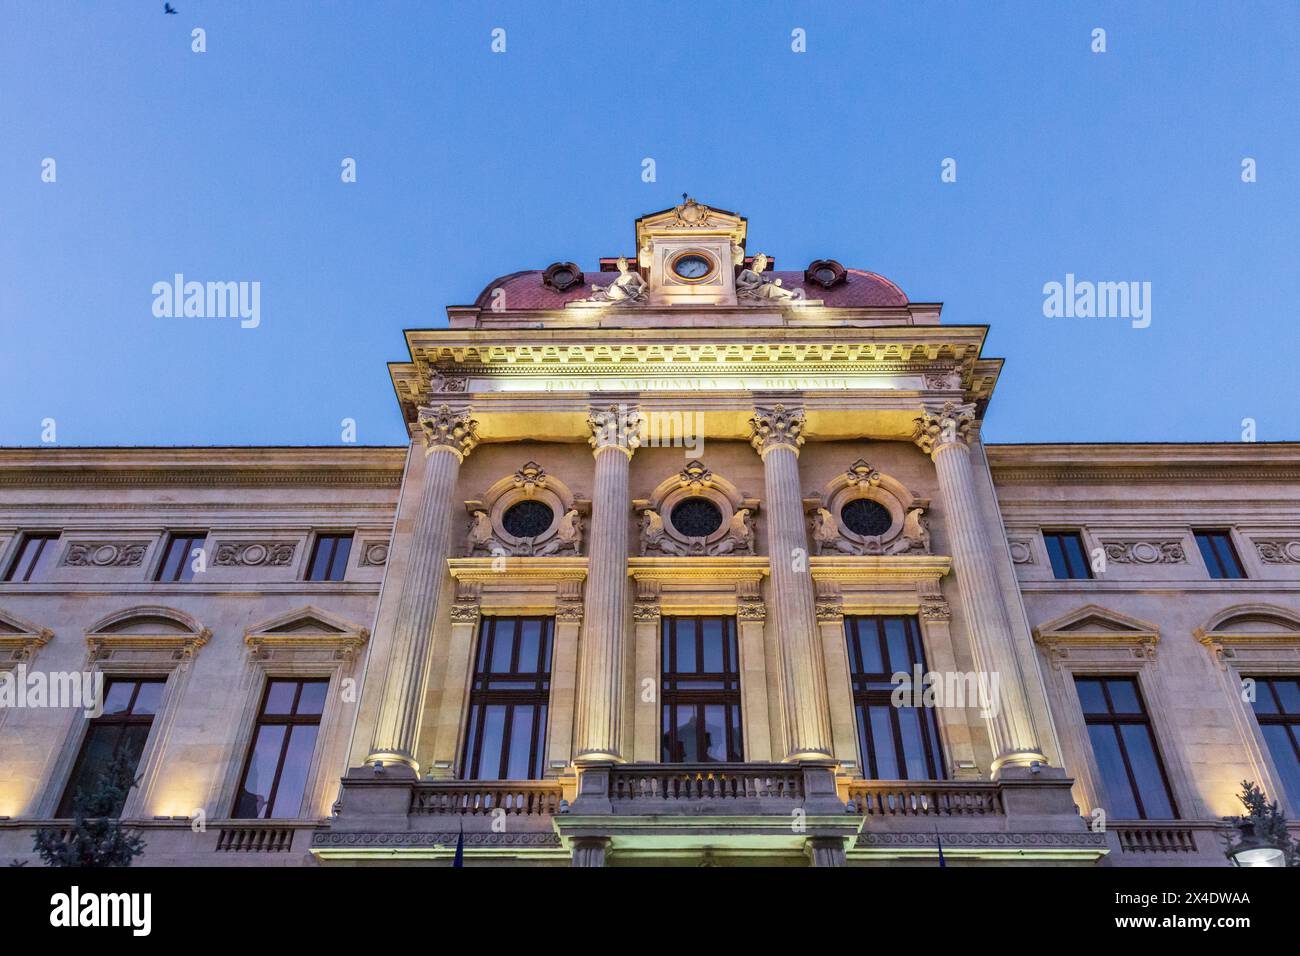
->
xmin=749 ymin=405 xmax=831 ymax=761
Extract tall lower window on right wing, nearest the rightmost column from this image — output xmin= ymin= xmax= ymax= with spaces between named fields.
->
xmin=1074 ymin=678 xmax=1178 ymax=819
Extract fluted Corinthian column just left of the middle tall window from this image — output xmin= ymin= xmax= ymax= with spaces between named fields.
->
xmin=575 ymin=406 xmax=641 ymax=761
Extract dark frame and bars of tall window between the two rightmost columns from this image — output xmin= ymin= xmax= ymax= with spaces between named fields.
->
xmin=841 ymin=614 xmax=948 ymax=780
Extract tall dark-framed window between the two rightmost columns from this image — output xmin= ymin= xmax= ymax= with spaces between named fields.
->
xmin=844 ymin=617 xmax=944 ymax=780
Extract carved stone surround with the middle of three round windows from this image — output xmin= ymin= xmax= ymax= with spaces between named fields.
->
xmin=633 ymin=460 xmax=758 ymax=557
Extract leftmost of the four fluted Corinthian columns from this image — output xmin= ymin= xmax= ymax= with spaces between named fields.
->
xmin=367 ymin=405 xmax=478 ymax=771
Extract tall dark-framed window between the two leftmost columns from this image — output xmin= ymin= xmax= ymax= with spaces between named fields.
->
xmin=462 ymin=618 xmax=554 ymax=780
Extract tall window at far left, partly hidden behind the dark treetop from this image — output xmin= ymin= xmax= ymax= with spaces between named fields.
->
xmin=56 ymin=678 xmax=165 ymax=817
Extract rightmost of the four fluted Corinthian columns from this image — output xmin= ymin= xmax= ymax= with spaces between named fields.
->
xmin=913 ymin=402 xmax=1047 ymax=771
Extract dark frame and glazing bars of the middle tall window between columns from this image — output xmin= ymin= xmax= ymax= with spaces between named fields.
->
xmin=658 ymin=614 xmax=745 ymax=766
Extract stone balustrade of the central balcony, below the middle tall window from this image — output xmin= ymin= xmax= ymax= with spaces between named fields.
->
xmin=610 ymin=763 xmax=803 ymax=810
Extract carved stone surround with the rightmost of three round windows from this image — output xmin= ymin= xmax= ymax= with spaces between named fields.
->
xmin=805 ymin=458 xmax=930 ymax=555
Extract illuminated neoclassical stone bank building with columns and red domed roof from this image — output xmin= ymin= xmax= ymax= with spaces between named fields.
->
xmin=0 ymin=200 xmax=1300 ymax=866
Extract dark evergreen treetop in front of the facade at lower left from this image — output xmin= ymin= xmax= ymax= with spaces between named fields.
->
xmin=34 ymin=753 xmax=144 ymax=866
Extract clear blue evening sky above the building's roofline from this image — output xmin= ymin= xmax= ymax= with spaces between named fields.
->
xmin=0 ymin=0 xmax=1300 ymax=445
